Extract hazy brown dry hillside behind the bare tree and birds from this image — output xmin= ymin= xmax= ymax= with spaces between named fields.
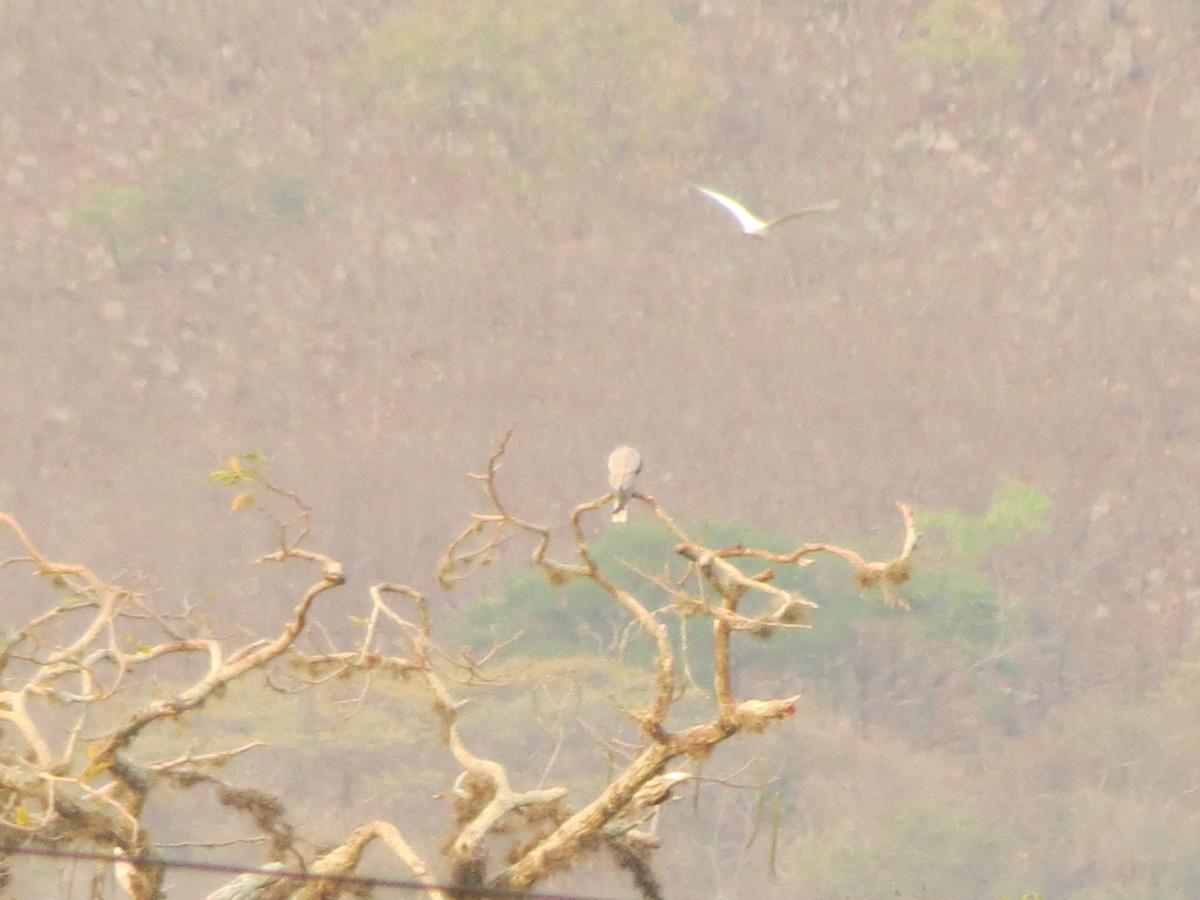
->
xmin=7 ymin=0 xmax=1200 ymax=900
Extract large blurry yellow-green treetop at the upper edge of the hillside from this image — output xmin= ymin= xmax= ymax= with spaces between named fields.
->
xmin=342 ymin=0 xmax=715 ymax=188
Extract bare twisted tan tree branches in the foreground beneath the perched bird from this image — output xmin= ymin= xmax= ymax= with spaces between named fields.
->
xmin=0 ymin=430 xmax=917 ymax=900
